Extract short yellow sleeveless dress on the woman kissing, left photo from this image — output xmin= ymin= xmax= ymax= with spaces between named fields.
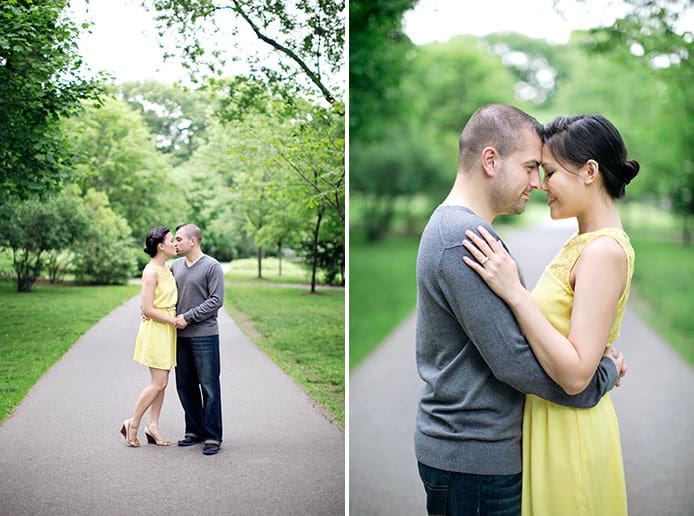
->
xmin=133 ymin=263 xmax=178 ymax=370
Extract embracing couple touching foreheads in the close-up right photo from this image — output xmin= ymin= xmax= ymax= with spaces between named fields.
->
xmin=415 ymin=104 xmax=639 ymax=516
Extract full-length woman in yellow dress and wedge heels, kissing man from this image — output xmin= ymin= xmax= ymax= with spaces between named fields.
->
xmin=120 ymin=226 xmax=178 ymax=447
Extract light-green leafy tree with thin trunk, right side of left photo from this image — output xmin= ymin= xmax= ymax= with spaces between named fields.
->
xmin=222 ymin=93 xmax=345 ymax=292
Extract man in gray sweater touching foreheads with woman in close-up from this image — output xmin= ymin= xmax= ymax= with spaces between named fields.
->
xmin=415 ymin=104 xmax=622 ymax=515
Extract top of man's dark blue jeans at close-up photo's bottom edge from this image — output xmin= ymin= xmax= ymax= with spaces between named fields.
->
xmin=419 ymin=462 xmax=523 ymax=516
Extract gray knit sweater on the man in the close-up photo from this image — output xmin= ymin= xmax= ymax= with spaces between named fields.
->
xmin=415 ymin=206 xmax=617 ymax=475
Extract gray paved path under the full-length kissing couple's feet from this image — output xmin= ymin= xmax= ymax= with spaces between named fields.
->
xmin=0 ymin=296 xmax=345 ymax=516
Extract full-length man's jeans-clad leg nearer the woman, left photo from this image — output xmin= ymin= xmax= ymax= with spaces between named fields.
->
xmin=176 ymin=337 xmax=204 ymax=444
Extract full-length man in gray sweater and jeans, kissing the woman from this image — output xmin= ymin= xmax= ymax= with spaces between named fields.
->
xmin=171 ymin=224 xmax=224 ymax=455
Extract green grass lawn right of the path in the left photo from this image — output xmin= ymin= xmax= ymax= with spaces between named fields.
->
xmin=225 ymin=285 xmax=345 ymax=428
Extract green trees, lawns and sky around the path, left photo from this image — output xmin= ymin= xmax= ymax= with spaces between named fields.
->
xmin=0 ymin=0 xmax=346 ymax=428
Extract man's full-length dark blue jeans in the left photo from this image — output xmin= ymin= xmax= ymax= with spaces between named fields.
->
xmin=176 ymin=335 xmax=222 ymax=444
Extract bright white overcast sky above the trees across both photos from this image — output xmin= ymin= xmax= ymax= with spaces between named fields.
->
xmin=73 ymin=0 xmax=694 ymax=83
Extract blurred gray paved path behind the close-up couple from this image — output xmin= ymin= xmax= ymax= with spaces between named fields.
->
xmin=349 ymin=222 xmax=694 ymax=516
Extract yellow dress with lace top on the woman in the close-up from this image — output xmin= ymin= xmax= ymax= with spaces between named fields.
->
xmin=522 ymin=228 xmax=634 ymax=516
